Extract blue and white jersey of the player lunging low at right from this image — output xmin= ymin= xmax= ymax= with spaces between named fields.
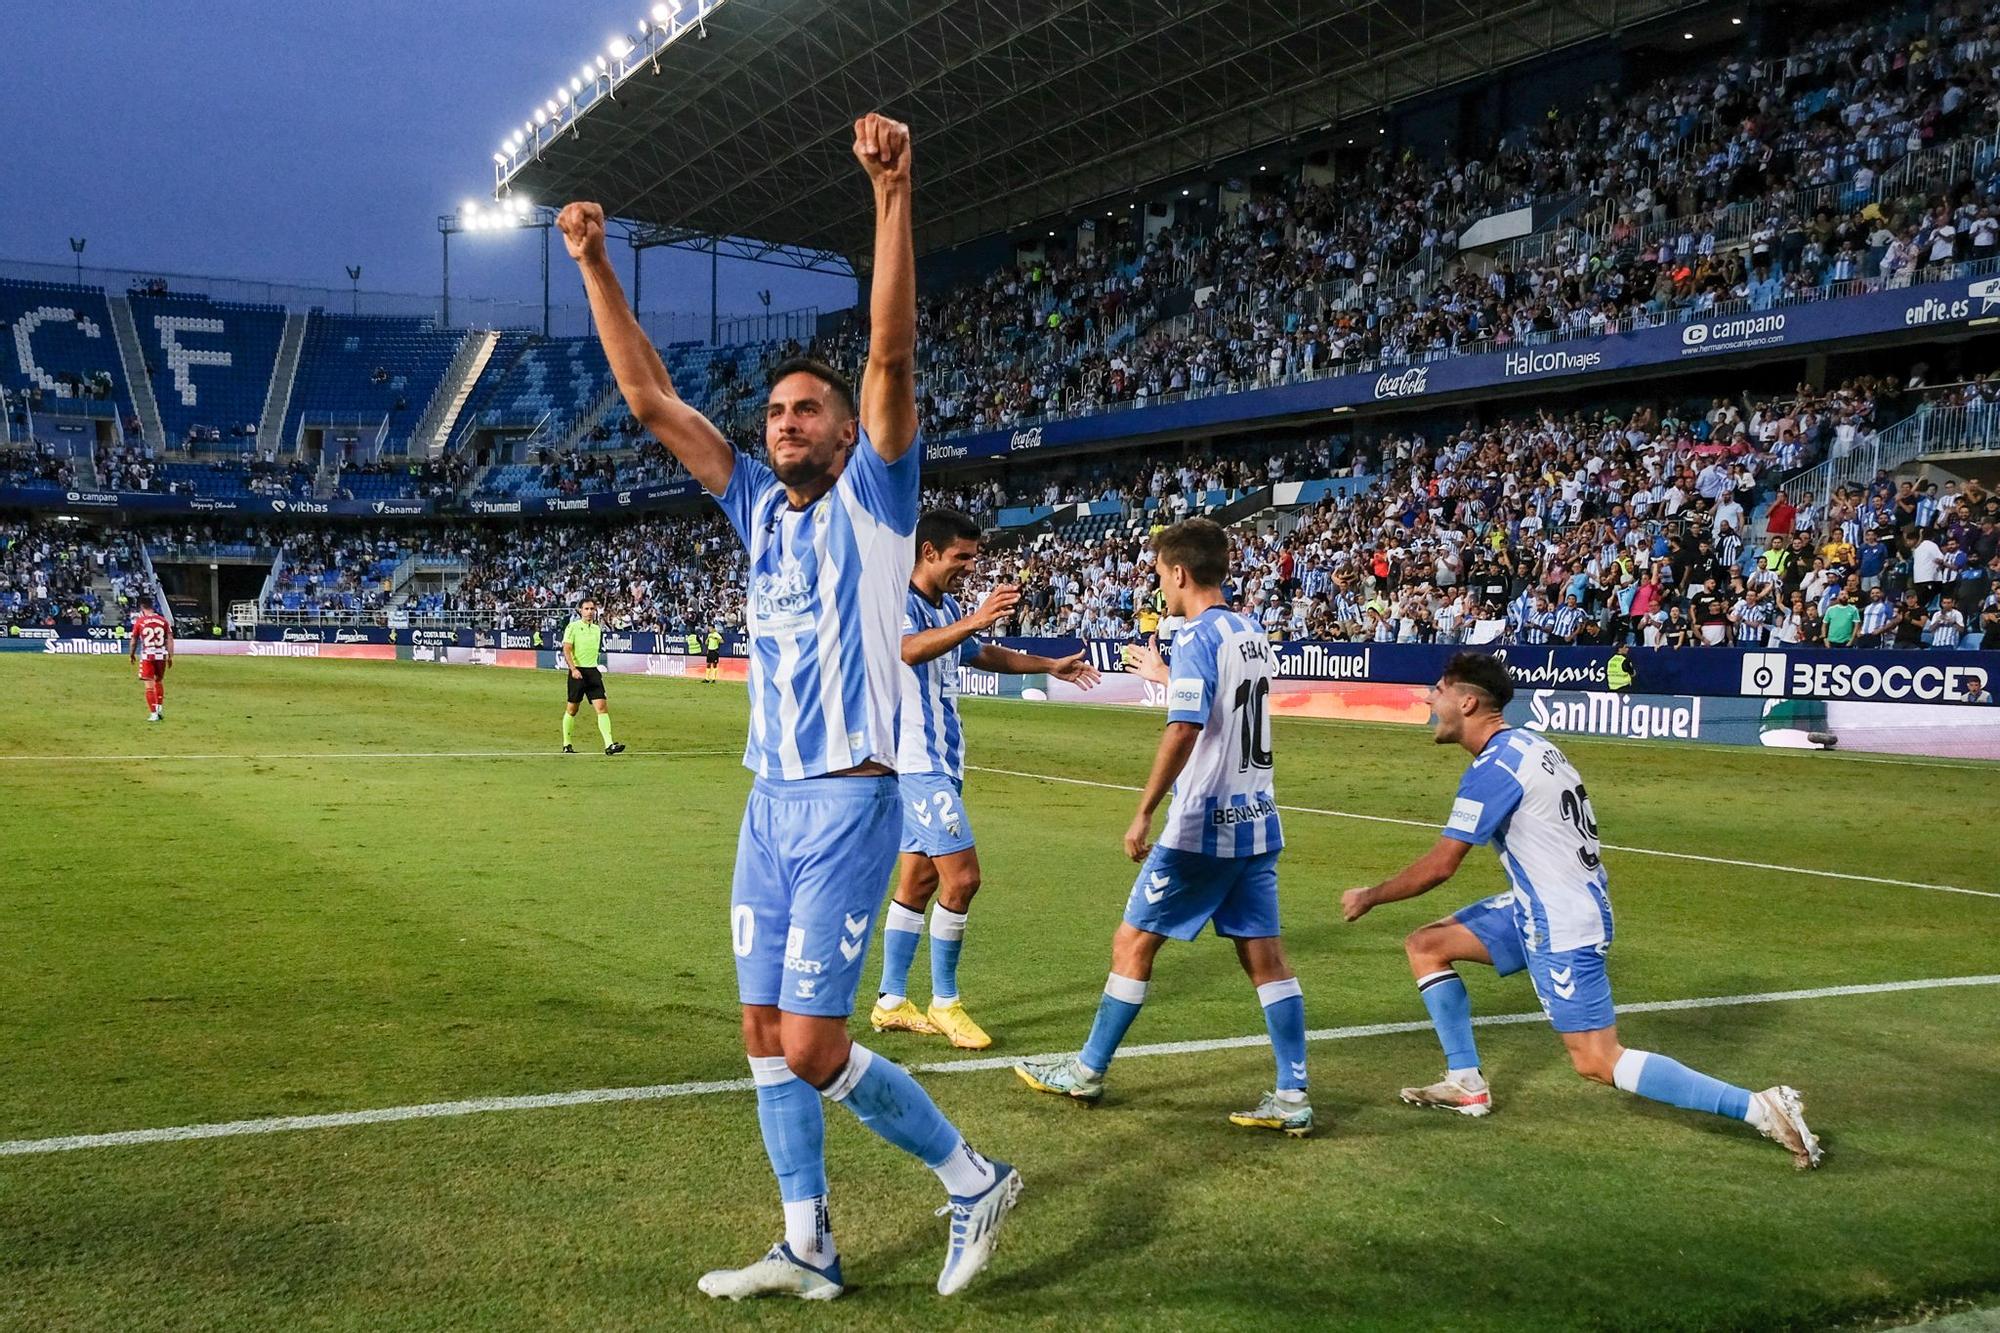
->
xmin=1444 ymin=727 xmax=1612 ymax=953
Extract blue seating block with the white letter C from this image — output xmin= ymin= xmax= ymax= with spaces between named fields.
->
xmin=0 ymin=280 xmax=130 ymax=412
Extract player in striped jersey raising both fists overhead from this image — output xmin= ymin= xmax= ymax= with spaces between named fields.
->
xmin=558 ymin=116 xmax=1020 ymax=1301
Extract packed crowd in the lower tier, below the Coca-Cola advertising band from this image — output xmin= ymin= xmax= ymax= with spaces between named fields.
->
xmin=10 ymin=368 xmax=2000 ymax=646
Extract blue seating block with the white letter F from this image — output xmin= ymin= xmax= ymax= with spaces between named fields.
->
xmin=130 ymin=292 xmax=284 ymax=452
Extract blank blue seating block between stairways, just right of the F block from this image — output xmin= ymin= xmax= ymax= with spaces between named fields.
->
xmin=284 ymin=310 xmax=466 ymax=454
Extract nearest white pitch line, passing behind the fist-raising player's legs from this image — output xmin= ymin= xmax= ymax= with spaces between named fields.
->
xmin=0 ymin=973 xmax=2000 ymax=1157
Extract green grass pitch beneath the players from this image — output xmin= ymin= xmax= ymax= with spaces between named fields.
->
xmin=0 ymin=654 xmax=2000 ymax=1333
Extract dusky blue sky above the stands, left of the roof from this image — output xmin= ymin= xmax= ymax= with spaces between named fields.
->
xmin=0 ymin=0 xmax=854 ymax=330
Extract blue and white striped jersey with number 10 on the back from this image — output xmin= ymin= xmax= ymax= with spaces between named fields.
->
xmin=1160 ymin=606 xmax=1284 ymax=857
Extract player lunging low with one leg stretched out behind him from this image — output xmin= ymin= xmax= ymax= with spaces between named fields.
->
xmin=1340 ymin=652 xmax=1820 ymax=1169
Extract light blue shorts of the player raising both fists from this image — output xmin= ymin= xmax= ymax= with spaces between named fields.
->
xmin=730 ymin=777 xmax=898 ymax=1019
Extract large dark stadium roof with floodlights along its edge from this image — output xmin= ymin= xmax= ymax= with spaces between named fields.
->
xmin=494 ymin=0 xmax=1692 ymax=266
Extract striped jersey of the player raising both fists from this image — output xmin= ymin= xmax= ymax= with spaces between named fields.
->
xmin=716 ymin=430 xmax=924 ymax=779
